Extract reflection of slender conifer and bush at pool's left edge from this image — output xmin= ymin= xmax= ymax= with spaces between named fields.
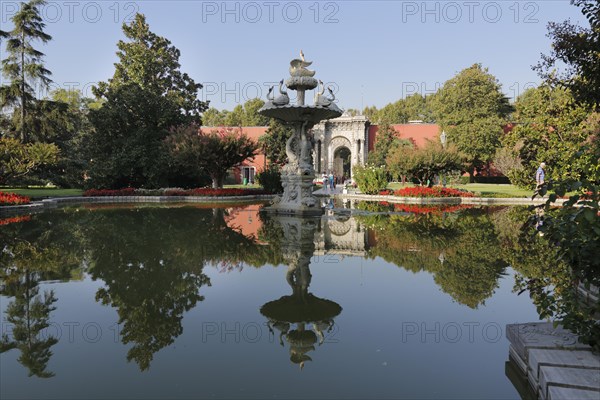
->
xmin=0 ymin=216 xmax=80 ymax=378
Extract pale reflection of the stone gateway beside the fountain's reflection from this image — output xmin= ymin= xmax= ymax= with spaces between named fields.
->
xmin=315 ymin=214 xmax=369 ymax=257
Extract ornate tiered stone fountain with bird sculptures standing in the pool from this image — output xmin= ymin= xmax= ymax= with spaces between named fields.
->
xmin=258 ymin=51 xmax=342 ymax=215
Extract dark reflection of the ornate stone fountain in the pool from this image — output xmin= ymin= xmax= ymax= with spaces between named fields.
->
xmin=260 ymin=216 xmax=342 ymax=369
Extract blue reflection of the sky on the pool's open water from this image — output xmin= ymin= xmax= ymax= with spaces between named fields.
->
xmin=0 ymin=205 xmax=538 ymax=399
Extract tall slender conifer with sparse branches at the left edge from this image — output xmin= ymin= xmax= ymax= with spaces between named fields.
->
xmin=0 ymin=0 xmax=52 ymax=142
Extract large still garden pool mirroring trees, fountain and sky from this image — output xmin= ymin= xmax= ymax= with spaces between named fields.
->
xmin=0 ymin=203 xmax=539 ymax=399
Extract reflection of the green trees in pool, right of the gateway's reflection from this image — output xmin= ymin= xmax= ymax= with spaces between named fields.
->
xmin=357 ymin=209 xmax=507 ymax=308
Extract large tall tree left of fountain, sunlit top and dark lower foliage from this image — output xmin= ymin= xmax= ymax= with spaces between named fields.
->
xmin=86 ymin=14 xmax=207 ymax=188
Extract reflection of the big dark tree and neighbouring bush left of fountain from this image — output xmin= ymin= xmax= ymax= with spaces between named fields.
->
xmin=86 ymin=208 xmax=274 ymax=370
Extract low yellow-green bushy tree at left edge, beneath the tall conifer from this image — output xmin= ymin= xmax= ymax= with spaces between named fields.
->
xmin=0 ymin=139 xmax=60 ymax=184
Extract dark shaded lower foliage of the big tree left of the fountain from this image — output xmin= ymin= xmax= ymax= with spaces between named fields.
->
xmin=85 ymin=83 xmax=175 ymax=189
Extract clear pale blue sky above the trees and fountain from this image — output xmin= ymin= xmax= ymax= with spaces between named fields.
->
xmin=0 ymin=0 xmax=585 ymax=109
